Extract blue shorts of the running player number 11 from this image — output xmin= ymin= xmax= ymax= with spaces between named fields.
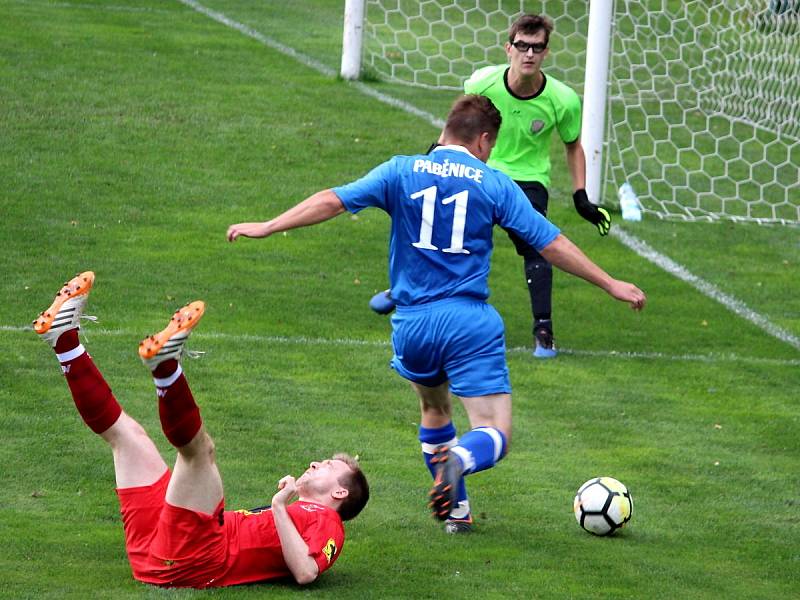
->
xmin=392 ymin=298 xmax=511 ymax=398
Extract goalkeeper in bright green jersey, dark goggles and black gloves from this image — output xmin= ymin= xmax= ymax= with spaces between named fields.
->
xmin=370 ymin=15 xmax=611 ymax=358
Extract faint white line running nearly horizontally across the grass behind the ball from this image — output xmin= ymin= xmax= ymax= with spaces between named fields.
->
xmin=0 ymin=325 xmax=800 ymax=366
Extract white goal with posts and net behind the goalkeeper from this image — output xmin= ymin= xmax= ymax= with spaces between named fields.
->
xmin=342 ymin=0 xmax=800 ymax=225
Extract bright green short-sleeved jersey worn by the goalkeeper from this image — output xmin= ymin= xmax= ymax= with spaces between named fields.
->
xmin=464 ymin=65 xmax=581 ymax=187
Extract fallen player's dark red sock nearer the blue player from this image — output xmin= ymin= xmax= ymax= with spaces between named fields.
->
xmin=153 ymin=360 xmax=203 ymax=448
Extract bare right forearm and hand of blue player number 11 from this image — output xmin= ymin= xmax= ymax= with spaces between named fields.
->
xmin=539 ymin=234 xmax=647 ymax=310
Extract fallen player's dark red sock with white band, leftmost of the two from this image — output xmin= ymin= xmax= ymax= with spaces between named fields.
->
xmin=55 ymin=329 xmax=122 ymax=433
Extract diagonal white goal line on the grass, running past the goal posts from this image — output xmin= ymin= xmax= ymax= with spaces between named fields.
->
xmin=178 ymin=0 xmax=800 ymax=350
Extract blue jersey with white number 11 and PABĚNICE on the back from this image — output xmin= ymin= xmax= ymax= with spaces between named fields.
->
xmin=333 ymin=146 xmax=559 ymax=306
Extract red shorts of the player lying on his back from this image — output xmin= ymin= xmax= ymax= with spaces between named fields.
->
xmin=117 ymin=469 xmax=228 ymax=587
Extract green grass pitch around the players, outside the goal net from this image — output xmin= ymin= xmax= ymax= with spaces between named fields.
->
xmin=0 ymin=0 xmax=800 ymax=599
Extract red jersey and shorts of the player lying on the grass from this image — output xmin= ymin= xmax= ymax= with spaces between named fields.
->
xmin=117 ymin=471 xmax=344 ymax=588
